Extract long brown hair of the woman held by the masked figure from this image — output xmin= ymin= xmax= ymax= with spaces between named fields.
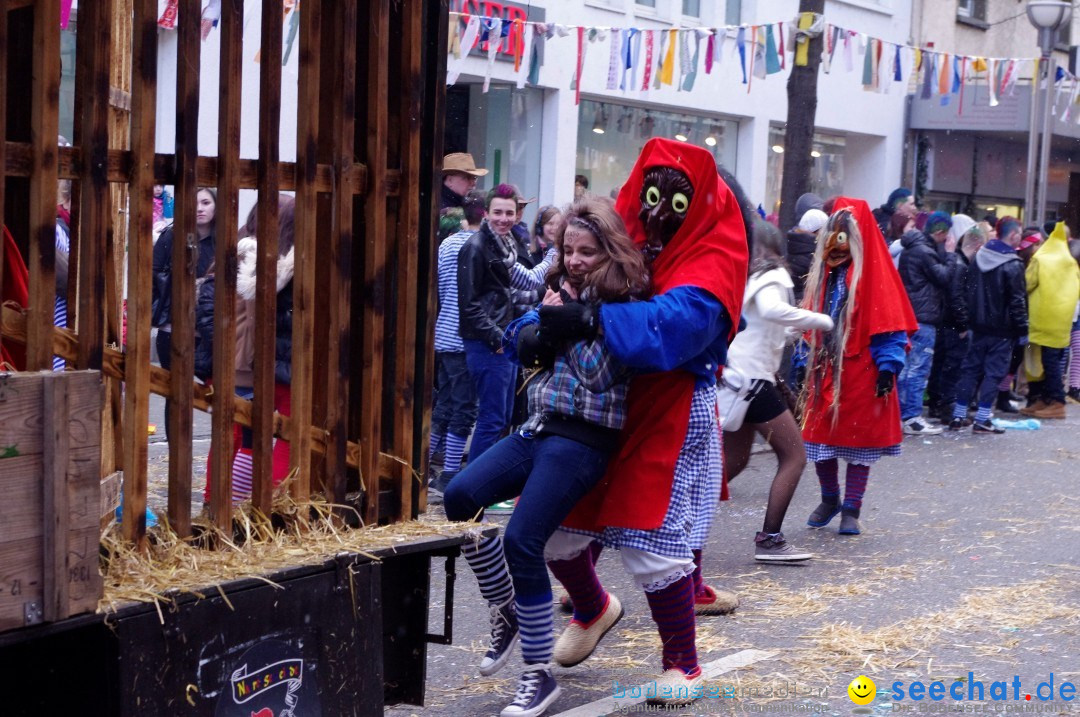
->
xmin=548 ymin=195 xmax=649 ymax=301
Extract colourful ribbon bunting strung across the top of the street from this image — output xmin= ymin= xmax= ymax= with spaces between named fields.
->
xmin=440 ymin=10 xmax=1080 ymax=113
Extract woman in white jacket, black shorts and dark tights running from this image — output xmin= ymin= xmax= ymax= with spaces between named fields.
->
xmin=724 ymin=221 xmax=833 ymax=562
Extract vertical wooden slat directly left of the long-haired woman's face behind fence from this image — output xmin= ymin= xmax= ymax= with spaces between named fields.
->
xmin=168 ymin=0 xmax=202 ymax=537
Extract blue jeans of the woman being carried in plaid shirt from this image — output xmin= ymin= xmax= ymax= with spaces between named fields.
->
xmin=443 ymin=429 xmax=613 ymax=597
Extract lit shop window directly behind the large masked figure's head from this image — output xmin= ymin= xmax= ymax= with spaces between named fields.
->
xmin=575 ymin=99 xmax=739 ymax=197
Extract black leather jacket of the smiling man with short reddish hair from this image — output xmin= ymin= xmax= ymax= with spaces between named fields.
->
xmin=458 ymin=221 xmax=514 ymax=351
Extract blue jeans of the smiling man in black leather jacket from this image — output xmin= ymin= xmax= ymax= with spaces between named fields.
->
xmin=464 ymin=339 xmax=517 ymax=463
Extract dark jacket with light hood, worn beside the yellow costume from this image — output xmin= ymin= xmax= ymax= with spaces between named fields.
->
xmin=967 ymin=241 xmax=1027 ymax=338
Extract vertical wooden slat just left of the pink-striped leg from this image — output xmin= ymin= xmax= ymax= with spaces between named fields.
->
xmin=211 ymin=0 xmax=244 ymax=530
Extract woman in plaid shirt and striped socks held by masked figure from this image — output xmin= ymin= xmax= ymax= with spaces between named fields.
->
xmin=444 ymin=198 xmax=648 ymax=717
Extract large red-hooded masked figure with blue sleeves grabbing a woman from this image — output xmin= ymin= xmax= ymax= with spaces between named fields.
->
xmin=540 ymin=138 xmax=747 ymax=704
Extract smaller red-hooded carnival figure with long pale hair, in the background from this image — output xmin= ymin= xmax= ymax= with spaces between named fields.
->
xmin=801 ymin=197 xmax=918 ymax=536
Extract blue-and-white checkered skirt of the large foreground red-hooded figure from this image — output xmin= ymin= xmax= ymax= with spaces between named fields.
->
xmin=602 ymin=387 xmax=723 ymax=559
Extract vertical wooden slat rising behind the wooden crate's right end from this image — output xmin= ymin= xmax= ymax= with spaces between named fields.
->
xmin=69 ymin=0 xmax=112 ymax=369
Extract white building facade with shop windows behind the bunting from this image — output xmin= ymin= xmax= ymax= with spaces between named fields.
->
xmin=445 ymin=0 xmax=912 ymax=222
